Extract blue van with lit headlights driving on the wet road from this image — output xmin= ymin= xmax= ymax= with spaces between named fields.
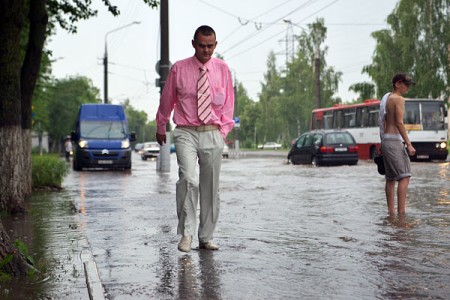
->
xmin=71 ymin=104 xmax=136 ymax=171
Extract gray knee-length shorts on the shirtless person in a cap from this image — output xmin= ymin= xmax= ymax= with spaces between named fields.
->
xmin=381 ymin=139 xmax=411 ymax=181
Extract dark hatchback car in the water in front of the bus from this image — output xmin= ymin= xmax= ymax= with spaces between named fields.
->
xmin=287 ymin=129 xmax=358 ymax=165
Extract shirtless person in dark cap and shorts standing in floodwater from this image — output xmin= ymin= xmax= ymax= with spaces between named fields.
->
xmin=380 ymin=73 xmax=416 ymax=217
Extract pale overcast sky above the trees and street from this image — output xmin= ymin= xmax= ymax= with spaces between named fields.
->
xmin=47 ymin=0 xmax=398 ymax=120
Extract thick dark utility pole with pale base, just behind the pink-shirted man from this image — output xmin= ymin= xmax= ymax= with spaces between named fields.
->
xmin=156 ymin=0 xmax=170 ymax=172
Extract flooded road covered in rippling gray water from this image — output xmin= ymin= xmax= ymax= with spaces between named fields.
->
xmin=1 ymin=154 xmax=450 ymax=299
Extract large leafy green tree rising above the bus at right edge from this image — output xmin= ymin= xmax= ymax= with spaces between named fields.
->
xmin=363 ymin=0 xmax=450 ymax=98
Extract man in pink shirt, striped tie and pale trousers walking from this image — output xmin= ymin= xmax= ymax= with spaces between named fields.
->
xmin=156 ymin=25 xmax=234 ymax=252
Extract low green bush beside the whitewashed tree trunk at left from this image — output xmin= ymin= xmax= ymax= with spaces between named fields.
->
xmin=32 ymin=154 xmax=69 ymax=188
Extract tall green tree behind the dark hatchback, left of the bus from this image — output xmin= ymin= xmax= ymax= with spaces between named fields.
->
xmin=256 ymin=19 xmax=342 ymax=146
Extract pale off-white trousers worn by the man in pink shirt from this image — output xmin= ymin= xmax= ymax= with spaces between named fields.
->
xmin=173 ymin=127 xmax=224 ymax=243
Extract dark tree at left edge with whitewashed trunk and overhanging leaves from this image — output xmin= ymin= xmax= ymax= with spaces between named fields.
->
xmin=0 ymin=0 xmax=158 ymax=274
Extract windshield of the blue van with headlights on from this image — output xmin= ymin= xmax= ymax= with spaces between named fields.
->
xmin=80 ymin=121 xmax=127 ymax=139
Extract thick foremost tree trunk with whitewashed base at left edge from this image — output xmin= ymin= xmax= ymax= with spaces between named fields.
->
xmin=0 ymin=0 xmax=24 ymax=212
